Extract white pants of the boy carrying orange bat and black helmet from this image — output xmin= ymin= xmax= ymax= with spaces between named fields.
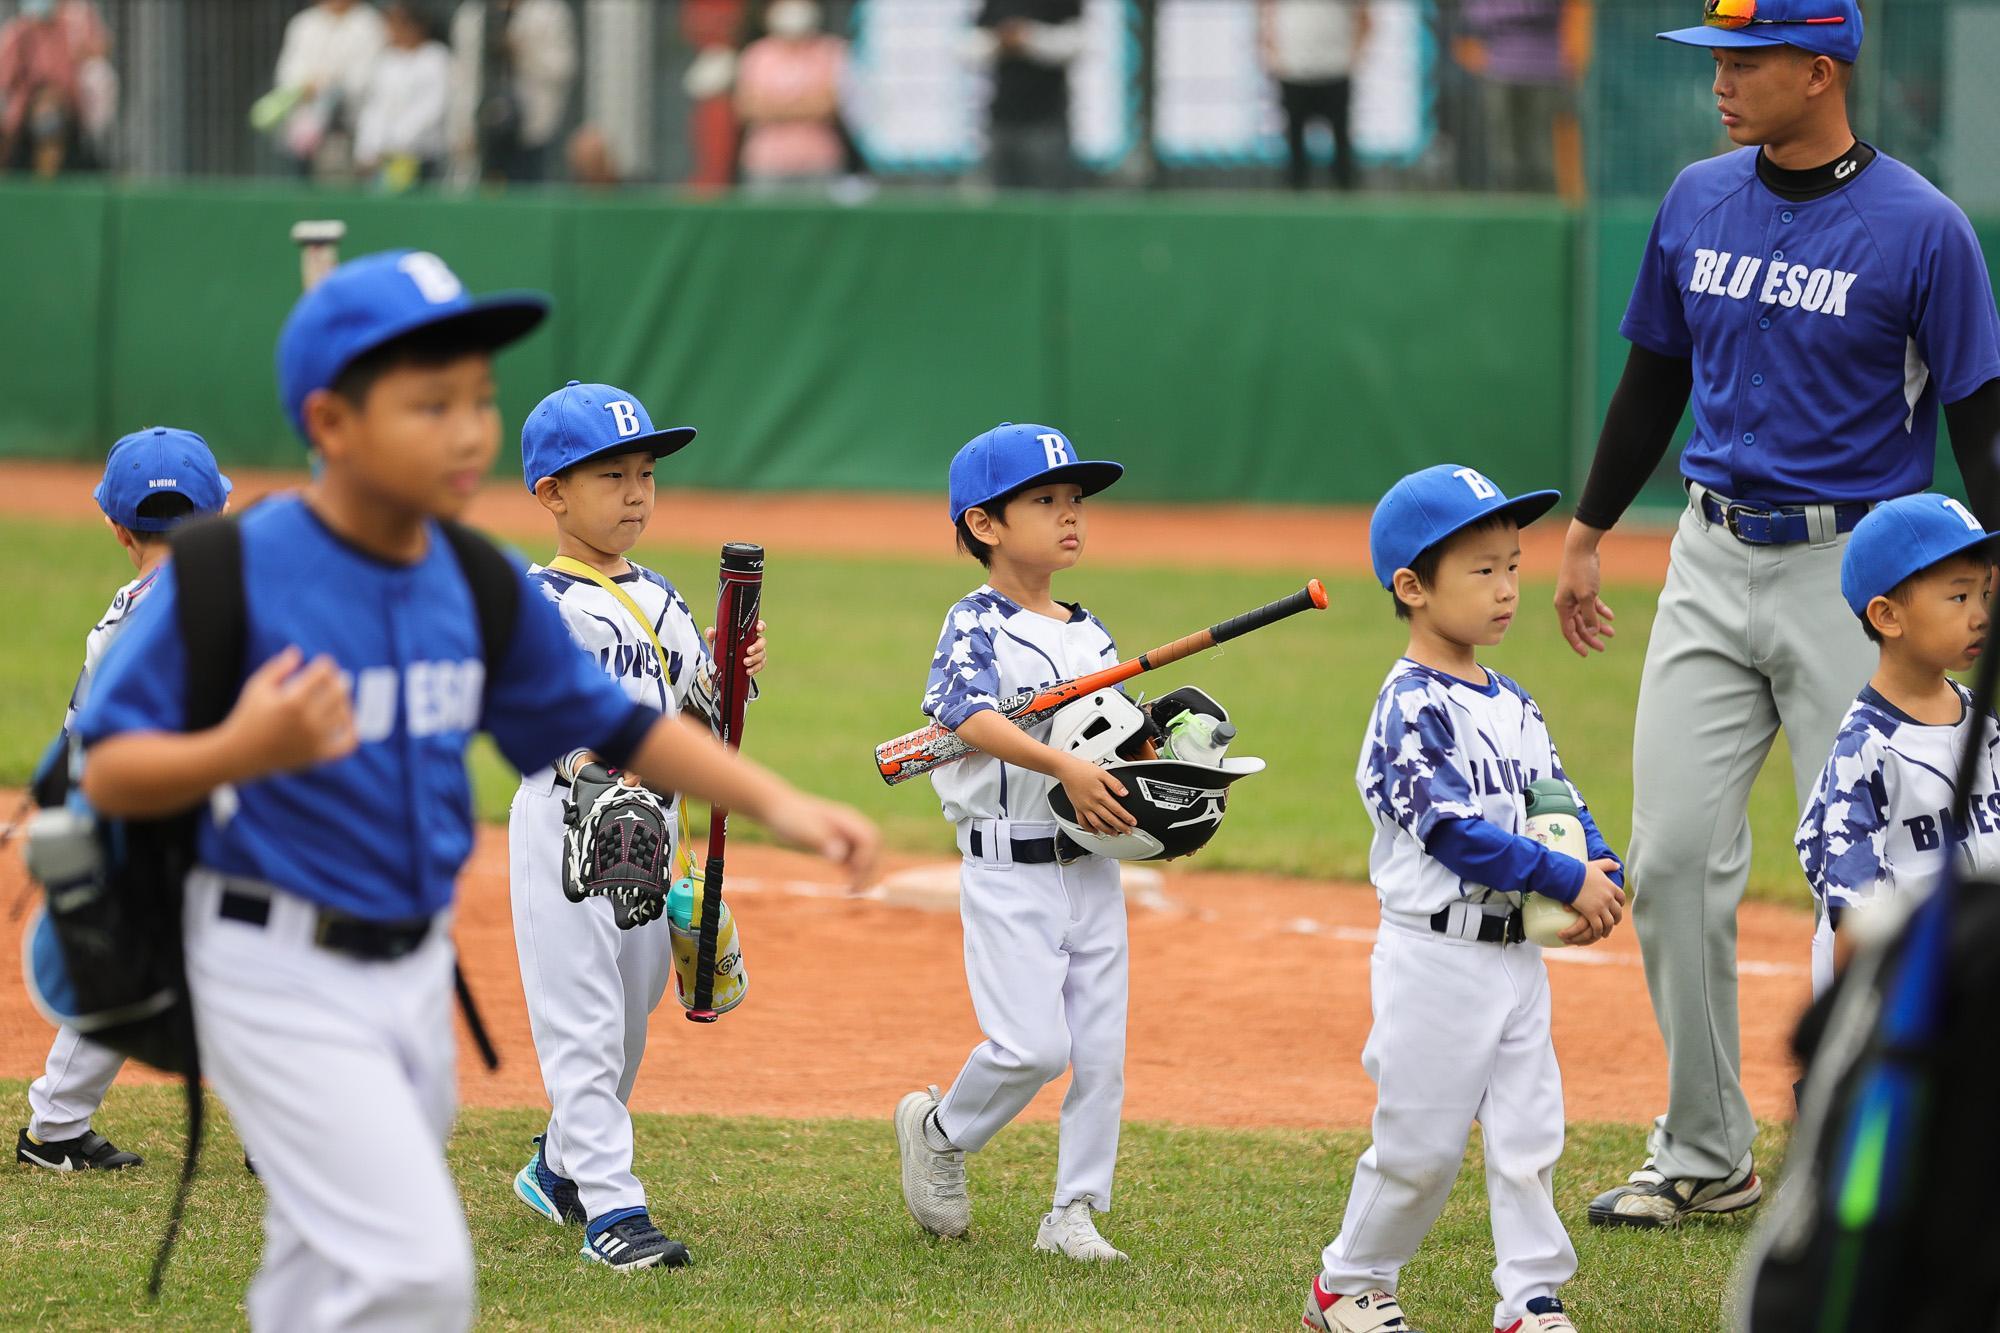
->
xmin=938 ymin=821 xmax=1126 ymax=1211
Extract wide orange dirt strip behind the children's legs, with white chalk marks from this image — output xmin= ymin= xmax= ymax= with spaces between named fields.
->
xmin=0 ymin=829 xmax=1812 ymax=1127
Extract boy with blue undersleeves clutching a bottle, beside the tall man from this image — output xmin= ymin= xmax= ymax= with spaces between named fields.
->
xmin=1304 ymin=464 xmax=1624 ymax=1333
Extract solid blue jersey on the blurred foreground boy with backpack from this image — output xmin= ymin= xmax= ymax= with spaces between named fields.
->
xmin=76 ymin=496 xmax=660 ymax=921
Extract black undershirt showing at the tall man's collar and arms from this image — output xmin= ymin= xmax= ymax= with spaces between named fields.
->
xmin=1576 ymin=140 xmax=2000 ymax=528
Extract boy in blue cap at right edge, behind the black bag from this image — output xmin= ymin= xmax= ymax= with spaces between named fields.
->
xmin=1794 ymin=492 xmax=2000 ymax=995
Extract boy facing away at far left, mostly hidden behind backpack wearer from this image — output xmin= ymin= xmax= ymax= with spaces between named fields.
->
xmin=14 ymin=426 xmax=230 ymax=1171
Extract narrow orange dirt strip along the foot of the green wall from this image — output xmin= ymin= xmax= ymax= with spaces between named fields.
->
xmin=0 ymin=462 xmax=1668 ymax=582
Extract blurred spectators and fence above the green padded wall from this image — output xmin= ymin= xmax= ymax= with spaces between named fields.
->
xmin=0 ymin=0 xmax=2000 ymax=200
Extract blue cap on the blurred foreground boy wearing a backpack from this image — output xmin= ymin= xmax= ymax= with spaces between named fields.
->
xmin=278 ymin=250 xmax=548 ymax=444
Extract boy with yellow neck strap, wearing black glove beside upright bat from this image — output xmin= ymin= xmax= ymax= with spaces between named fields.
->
xmin=508 ymin=380 xmax=764 ymax=1271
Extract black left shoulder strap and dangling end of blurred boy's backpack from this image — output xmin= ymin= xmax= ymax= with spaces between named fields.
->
xmin=146 ymin=518 xmax=250 ymax=1299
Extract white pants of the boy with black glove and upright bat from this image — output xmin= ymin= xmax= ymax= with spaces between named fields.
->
xmin=506 ymin=787 xmax=674 ymax=1217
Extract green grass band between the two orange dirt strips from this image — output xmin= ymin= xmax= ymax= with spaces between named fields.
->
xmin=0 ymin=514 xmax=1808 ymax=907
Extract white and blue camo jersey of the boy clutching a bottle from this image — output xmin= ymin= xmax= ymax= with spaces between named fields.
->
xmin=1354 ymin=658 xmax=1584 ymax=917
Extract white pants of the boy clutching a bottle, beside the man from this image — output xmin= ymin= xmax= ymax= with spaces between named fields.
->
xmin=1320 ymin=913 xmax=1576 ymax=1327
